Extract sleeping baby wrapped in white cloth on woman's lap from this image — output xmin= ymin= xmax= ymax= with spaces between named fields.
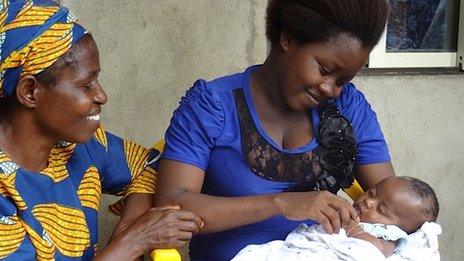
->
xmin=234 ymin=177 xmax=441 ymax=261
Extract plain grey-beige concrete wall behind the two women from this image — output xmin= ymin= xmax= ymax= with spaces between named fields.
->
xmin=61 ymin=0 xmax=464 ymax=260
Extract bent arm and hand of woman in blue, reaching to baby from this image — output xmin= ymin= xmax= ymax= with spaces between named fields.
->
xmin=155 ymin=160 xmax=357 ymax=233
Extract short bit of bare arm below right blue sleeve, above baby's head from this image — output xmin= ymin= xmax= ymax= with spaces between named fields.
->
xmin=355 ymin=161 xmax=395 ymax=191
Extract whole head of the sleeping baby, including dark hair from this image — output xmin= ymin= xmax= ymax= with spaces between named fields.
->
xmin=353 ymin=177 xmax=439 ymax=234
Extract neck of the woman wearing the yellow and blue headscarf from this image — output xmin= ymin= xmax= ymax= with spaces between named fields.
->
xmin=0 ymin=113 xmax=58 ymax=171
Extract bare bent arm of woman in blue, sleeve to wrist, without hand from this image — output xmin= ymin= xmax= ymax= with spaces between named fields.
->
xmin=155 ymin=160 xmax=279 ymax=232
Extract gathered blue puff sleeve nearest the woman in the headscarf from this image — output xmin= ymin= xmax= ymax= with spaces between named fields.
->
xmin=162 ymin=80 xmax=225 ymax=170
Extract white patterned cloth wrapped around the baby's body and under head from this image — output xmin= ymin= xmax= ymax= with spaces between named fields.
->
xmin=232 ymin=222 xmax=441 ymax=261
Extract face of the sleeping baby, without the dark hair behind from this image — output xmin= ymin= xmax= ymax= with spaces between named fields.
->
xmin=353 ymin=177 xmax=423 ymax=233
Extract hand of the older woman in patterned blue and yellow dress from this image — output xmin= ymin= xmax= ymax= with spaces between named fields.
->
xmin=108 ymin=206 xmax=204 ymax=258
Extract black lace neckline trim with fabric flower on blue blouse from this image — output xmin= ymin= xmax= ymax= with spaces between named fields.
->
xmin=234 ymin=88 xmax=356 ymax=193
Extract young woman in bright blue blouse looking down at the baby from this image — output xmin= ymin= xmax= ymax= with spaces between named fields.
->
xmin=157 ymin=0 xmax=394 ymax=261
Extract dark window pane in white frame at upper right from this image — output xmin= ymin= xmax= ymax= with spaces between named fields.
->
xmin=386 ymin=0 xmax=459 ymax=52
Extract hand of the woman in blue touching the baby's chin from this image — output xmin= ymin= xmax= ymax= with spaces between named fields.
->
xmin=275 ymin=191 xmax=359 ymax=234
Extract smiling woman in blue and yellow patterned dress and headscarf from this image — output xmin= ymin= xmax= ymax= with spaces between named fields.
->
xmin=0 ymin=0 xmax=202 ymax=260
